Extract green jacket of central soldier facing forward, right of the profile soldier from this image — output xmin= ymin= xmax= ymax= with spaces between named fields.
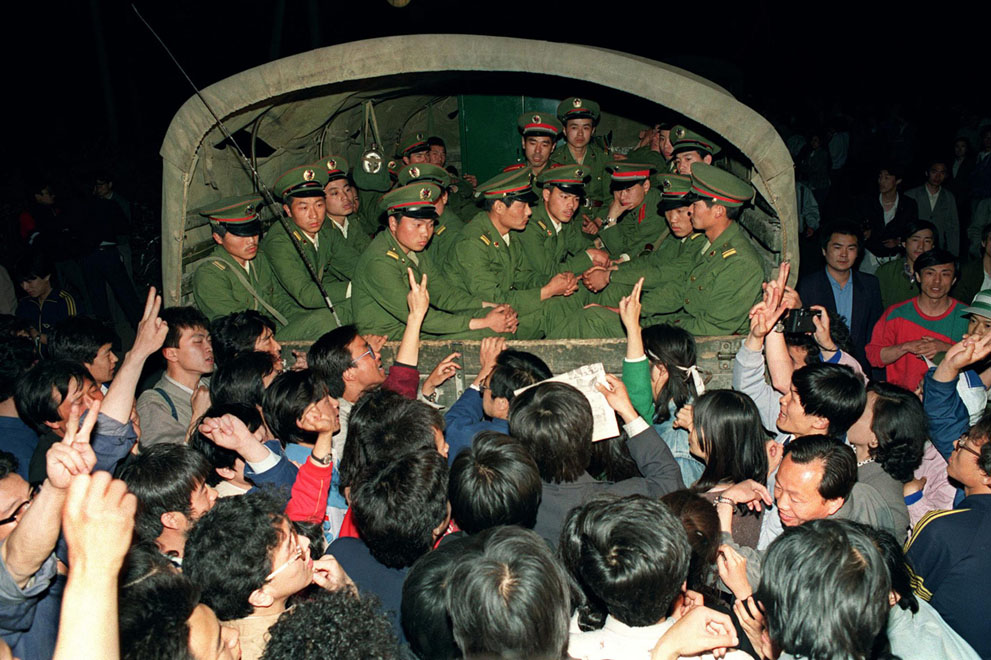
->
xmin=513 ymin=206 xmax=592 ymax=286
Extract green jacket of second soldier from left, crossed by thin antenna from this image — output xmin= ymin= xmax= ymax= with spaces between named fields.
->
xmin=261 ymin=223 xmax=348 ymax=312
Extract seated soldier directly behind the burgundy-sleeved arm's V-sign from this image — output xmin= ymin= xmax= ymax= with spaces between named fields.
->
xmin=351 ymin=182 xmax=517 ymax=339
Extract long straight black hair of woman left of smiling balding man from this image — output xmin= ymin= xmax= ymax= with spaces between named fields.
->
xmin=692 ymin=390 xmax=768 ymax=492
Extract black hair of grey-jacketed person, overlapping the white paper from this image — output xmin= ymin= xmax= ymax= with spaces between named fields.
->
xmin=509 ymin=382 xmax=592 ymax=484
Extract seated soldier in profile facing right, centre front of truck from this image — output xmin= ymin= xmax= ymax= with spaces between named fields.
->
xmin=449 ymin=168 xmax=622 ymax=339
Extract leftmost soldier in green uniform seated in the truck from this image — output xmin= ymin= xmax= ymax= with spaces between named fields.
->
xmin=193 ymin=194 xmax=333 ymax=341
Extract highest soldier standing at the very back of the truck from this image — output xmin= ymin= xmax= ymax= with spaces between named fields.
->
xmin=550 ymin=97 xmax=612 ymax=207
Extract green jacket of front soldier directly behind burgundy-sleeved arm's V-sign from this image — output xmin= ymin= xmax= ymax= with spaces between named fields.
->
xmin=351 ymin=231 xmax=486 ymax=339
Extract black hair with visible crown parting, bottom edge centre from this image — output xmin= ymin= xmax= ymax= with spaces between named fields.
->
xmin=447 ymin=527 xmax=571 ymax=660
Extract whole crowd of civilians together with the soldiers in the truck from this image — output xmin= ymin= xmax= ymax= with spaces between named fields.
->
xmin=0 ymin=98 xmax=991 ymax=660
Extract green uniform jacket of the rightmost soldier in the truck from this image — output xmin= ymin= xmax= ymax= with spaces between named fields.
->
xmin=645 ymin=222 xmax=764 ymax=336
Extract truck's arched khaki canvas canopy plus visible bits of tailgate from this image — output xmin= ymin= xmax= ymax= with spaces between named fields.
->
xmin=161 ymin=35 xmax=798 ymax=394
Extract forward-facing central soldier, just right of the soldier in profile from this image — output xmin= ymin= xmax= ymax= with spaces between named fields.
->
xmin=518 ymin=165 xmax=610 ymax=283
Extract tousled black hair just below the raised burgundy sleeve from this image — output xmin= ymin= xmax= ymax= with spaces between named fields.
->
xmin=338 ymin=388 xmax=444 ymax=493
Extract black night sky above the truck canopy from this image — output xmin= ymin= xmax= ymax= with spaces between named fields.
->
xmin=4 ymin=0 xmax=988 ymax=202
